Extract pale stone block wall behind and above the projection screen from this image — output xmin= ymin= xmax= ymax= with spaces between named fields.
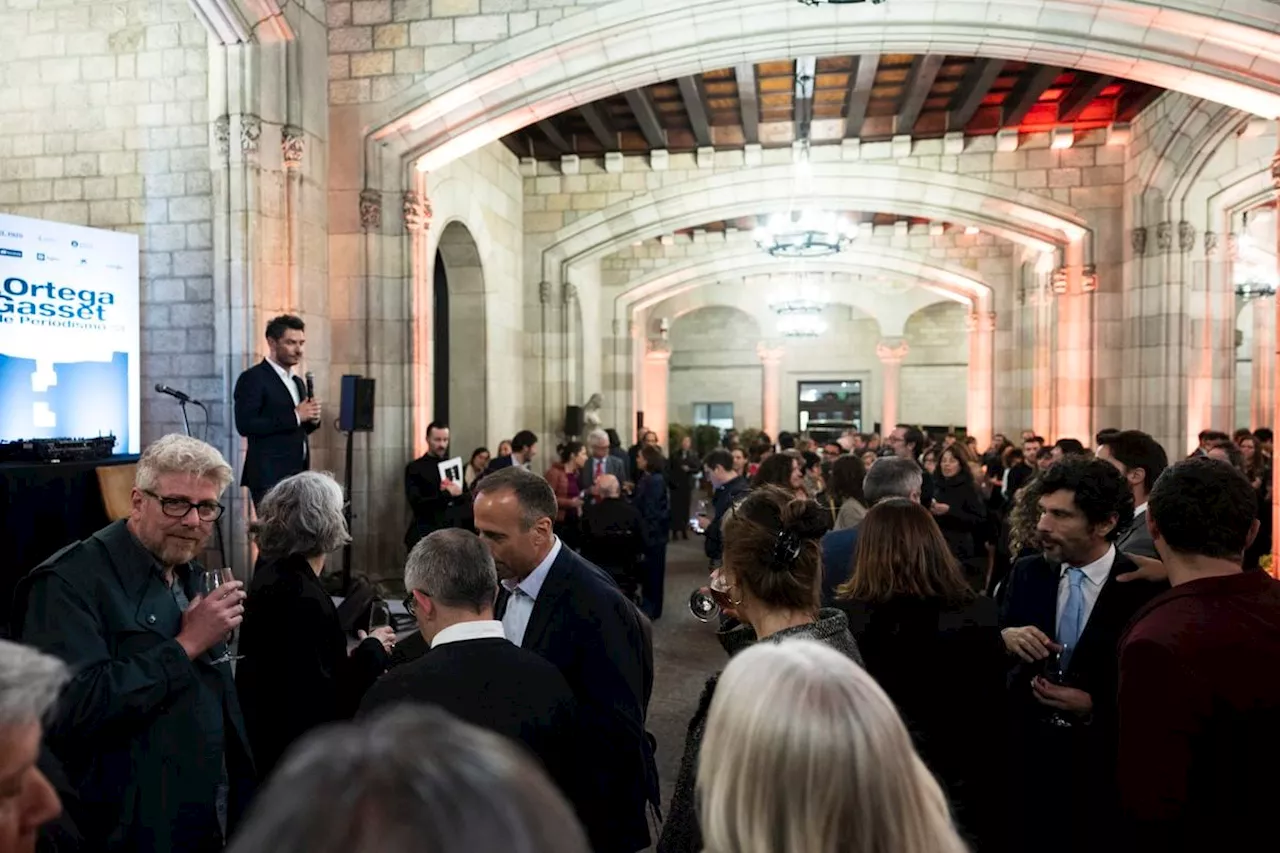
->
xmin=0 ymin=0 xmax=216 ymax=442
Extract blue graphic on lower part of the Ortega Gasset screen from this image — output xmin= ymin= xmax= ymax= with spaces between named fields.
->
xmin=0 ymin=352 xmax=129 ymax=448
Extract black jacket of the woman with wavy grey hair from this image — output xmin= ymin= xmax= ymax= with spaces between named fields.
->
xmin=236 ymin=555 xmax=387 ymax=779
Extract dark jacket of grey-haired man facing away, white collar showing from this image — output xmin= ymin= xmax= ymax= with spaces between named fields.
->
xmin=360 ymin=638 xmax=588 ymax=820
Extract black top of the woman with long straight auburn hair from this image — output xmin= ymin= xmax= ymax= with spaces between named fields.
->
xmin=828 ymin=591 xmax=1007 ymax=853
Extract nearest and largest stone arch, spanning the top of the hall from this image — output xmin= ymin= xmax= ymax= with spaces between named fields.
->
xmin=367 ymin=0 xmax=1280 ymax=170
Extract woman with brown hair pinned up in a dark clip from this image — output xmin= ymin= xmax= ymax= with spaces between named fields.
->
xmin=658 ymin=485 xmax=861 ymax=853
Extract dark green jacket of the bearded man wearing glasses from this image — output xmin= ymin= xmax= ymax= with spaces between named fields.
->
xmin=13 ymin=521 xmax=253 ymax=853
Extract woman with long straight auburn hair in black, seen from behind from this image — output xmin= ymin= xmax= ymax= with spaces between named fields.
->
xmin=836 ymin=494 xmax=1007 ymax=852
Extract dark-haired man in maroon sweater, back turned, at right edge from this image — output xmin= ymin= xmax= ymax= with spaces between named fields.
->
xmin=1119 ymin=457 xmax=1280 ymax=853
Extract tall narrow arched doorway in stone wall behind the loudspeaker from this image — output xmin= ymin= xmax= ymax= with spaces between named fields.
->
xmin=431 ymin=220 xmax=489 ymax=456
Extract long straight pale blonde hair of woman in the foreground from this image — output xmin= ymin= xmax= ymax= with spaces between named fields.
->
xmin=698 ymin=639 xmax=965 ymax=853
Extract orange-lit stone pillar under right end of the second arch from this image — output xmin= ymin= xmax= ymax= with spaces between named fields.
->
xmin=1046 ymin=240 xmax=1097 ymax=446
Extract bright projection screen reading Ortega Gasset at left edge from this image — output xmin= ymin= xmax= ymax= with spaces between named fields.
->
xmin=0 ymin=214 xmax=141 ymax=453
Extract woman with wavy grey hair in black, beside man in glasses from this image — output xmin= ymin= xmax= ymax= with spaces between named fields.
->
xmin=236 ymin=471 xmax=394 ymax=777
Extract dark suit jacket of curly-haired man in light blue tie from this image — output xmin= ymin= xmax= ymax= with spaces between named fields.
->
xmin=1000 ymin=552 xmax=1169 ymax=850
